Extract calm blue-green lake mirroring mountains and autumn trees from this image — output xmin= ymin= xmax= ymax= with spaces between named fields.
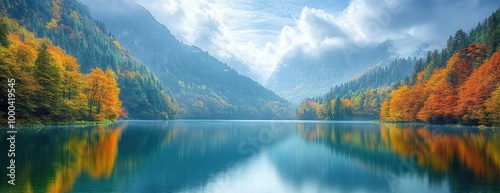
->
xmin=0 ymin=120 xmax=500 ymax=193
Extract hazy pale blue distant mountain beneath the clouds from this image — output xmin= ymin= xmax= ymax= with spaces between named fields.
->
xmin=266 ymin=40 xmax=392 ymax=103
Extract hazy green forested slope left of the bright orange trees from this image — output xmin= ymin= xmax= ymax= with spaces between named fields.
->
xmin=296 ymin=58 xmax=414 ymax=120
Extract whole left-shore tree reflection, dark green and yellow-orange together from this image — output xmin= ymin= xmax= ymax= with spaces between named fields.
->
xmin=0 ymin=125 xmax=122 ymax=193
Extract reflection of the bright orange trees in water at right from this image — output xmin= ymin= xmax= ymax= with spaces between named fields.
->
xmin=380 ymin=125 xmax=500 ymax=191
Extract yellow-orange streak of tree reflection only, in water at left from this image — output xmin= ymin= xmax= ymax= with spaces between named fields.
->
xmin=47 ymin=126 xmax=122 ymax=192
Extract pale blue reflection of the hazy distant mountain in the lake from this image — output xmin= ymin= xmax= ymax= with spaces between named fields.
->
xmin=268 ymin=137 xmax=394 ymax=192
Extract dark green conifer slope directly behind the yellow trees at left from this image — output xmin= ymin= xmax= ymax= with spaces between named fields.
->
xmin=0 ymin=0 xmax=177 ymax=119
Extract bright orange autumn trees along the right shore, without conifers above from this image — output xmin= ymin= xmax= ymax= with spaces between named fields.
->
xmin=380 ymin=43 xmax=500 ymax=125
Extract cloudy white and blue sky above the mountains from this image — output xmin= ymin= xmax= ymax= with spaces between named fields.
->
xmin=135 ymin=0 xmax=500 ymax=83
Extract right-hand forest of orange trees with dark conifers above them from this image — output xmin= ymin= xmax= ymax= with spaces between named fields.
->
xmin=380 ymin=10 xmax=500 ymax=126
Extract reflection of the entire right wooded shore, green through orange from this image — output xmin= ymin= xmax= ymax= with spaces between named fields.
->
xmin=298 ymin=123 xmax=500 ymax=192
